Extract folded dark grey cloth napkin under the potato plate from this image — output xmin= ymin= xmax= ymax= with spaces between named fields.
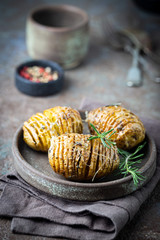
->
xmin=0 ymin=99 xmax=160 ymax=240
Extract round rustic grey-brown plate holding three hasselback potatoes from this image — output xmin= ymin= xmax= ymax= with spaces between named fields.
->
xmin=12 ymin=114 xmax=156 ymax=201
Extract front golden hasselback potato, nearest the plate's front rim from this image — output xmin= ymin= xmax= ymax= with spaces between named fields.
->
xmin=48 ymin=133 xmax=119 ymax=181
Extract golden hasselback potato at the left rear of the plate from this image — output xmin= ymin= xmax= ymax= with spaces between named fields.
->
xmin=23 ymin=106 xmax=83 ymax=152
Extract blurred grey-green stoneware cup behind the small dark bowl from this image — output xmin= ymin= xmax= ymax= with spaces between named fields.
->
xmin=26 ymin=5 xmax=89 ymax=69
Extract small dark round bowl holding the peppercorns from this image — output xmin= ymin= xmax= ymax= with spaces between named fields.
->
xmin=15 ymin=60 xmax=64 ymax=96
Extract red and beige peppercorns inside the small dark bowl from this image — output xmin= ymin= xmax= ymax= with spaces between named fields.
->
xmin=19 ymin=66 xmax=59 ymax=83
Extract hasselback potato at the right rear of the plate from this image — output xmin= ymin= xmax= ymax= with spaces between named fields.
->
xmin=87 ymin=106 xmax=145 ymax=150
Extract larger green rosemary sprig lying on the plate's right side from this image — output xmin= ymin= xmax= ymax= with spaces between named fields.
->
xmin=118 ymin=142 xmax=146 ymax=186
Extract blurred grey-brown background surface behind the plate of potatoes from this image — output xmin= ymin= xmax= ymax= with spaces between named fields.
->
xmin=0 ymin=0 xmax=160 ymax=239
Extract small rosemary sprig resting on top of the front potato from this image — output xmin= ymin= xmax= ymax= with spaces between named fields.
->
xmin=88 ymin=123 xmax=116 ymax=148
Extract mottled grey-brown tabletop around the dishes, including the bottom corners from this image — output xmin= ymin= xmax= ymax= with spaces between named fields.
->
xmin=0 ymin=0 xmax=160 ymax=240
